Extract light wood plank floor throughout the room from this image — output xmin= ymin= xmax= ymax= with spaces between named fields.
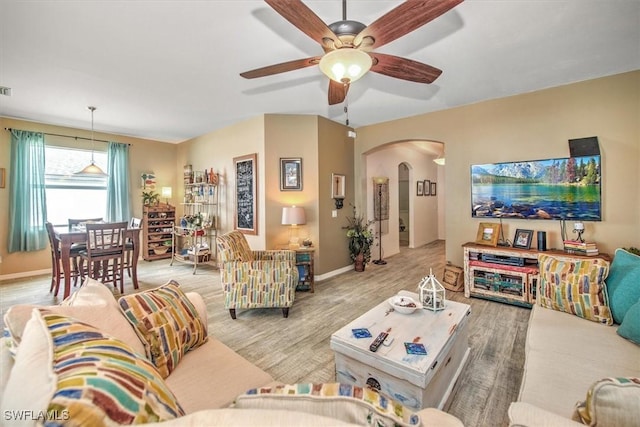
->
xmin=0 ymin=241 xmax=529 ymax=426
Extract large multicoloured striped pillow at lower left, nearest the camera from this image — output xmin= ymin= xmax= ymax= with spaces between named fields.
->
xmin=41 ymin=310 xmax=184 ymax=426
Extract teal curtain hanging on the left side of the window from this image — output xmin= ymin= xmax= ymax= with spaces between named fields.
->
xmin=7 ymin=129 xmax=49 ymax=253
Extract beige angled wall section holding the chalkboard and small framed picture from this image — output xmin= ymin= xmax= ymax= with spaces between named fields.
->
xmin=176 ymin=114 xmax=353 ymax=275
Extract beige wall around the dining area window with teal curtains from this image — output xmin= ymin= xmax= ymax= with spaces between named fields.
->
xmin=0 ymin=117 xmax=176 ymax=278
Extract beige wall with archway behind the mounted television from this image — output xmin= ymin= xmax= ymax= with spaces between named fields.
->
xmin=355 ymin=71 xmax=640 ymax=264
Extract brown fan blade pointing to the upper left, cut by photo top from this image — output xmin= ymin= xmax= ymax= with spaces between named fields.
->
xmin=265 ymin=0 xmax=342 ymax=48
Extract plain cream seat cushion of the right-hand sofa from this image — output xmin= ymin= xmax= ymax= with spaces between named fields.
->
xmin=518 ymin=305 xmax=640 ymax=419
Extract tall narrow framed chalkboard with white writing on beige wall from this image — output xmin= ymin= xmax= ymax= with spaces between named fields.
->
xmin=233 ymin=153 xmax=258 ymax=234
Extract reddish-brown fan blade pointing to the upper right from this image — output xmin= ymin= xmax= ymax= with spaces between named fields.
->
xmin=354 ymin=0 xmax=463 ymax=49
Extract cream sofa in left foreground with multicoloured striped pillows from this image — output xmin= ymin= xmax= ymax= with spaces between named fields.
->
xmin=0 ymin=279 xmax=462 ymax=426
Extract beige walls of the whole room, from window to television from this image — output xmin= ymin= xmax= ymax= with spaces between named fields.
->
xmin=0 ymin=71 xmax=640 ymax=278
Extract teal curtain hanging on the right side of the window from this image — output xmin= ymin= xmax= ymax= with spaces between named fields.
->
xmin=106 ymin=142 xmax=131 ymax=222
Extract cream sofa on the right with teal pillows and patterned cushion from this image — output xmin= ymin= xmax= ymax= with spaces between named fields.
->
xmin=509 ymin=249 xmax=640 ymax=427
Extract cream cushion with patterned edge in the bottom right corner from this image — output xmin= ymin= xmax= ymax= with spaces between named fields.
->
xmin=573 ymin=377 xmax=640 ymax=426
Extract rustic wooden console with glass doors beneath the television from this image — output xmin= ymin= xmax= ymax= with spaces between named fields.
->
xmin=462 ymin=243 xmax=610 ymax=308
